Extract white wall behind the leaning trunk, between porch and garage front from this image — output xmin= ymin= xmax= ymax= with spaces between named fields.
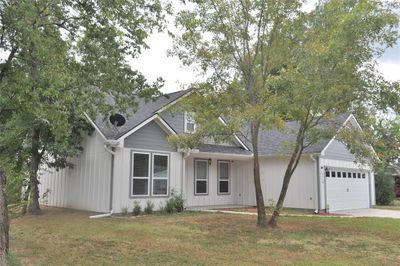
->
xmin=260 ymin=155 xmax=317 ymax=209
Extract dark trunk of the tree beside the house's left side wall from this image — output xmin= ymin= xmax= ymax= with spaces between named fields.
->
xmin=28 ymin=129 xmax=41 ymax=214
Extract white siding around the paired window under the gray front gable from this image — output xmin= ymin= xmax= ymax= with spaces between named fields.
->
xmin=113 ymin=148 xmax=182 ymax=213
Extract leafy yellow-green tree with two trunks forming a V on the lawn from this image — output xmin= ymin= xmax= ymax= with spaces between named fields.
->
xmin=172 ymin=0 xmax=398 ymax=227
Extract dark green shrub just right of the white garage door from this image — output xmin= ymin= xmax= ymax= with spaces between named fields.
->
xmin=375 ymin=172 xmax=395 ymax=205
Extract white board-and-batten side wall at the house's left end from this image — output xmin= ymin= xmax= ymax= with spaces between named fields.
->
xmin=39 ymin=131 xmax=111 ymax=212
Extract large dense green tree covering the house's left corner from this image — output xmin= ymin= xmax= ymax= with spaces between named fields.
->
xmin=0 ymin=0 xmax=165 ymax=258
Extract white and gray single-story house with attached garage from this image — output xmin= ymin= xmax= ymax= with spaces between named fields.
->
xmin=39 ymin=91 xmax=375 ymax=213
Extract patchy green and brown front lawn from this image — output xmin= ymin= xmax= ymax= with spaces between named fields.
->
xmin=11 ymin=209 xmax=400 ymax=265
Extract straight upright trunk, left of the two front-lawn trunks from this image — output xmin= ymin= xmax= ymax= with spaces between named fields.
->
xmin=251 ymin=122 xmax=267 ymax=227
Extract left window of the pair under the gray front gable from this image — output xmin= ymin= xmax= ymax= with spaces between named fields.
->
xmin=132 ymin=152 xmax=150 ymax=196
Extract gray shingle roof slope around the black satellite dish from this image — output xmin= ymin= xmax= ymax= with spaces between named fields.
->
xmin=94 ymin=90 xmax=188 ymax=139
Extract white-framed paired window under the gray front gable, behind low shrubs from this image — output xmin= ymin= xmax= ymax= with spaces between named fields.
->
xmin=131 ymin=151 xmax=169 ymax=197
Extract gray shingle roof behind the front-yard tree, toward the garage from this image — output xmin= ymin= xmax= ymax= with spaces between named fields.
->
xmin=238 ymin=113 xmax=350 ymax=156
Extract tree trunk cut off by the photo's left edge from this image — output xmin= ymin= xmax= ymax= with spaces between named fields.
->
xmin=0 ymin=169 xmax=10 ymax=265
